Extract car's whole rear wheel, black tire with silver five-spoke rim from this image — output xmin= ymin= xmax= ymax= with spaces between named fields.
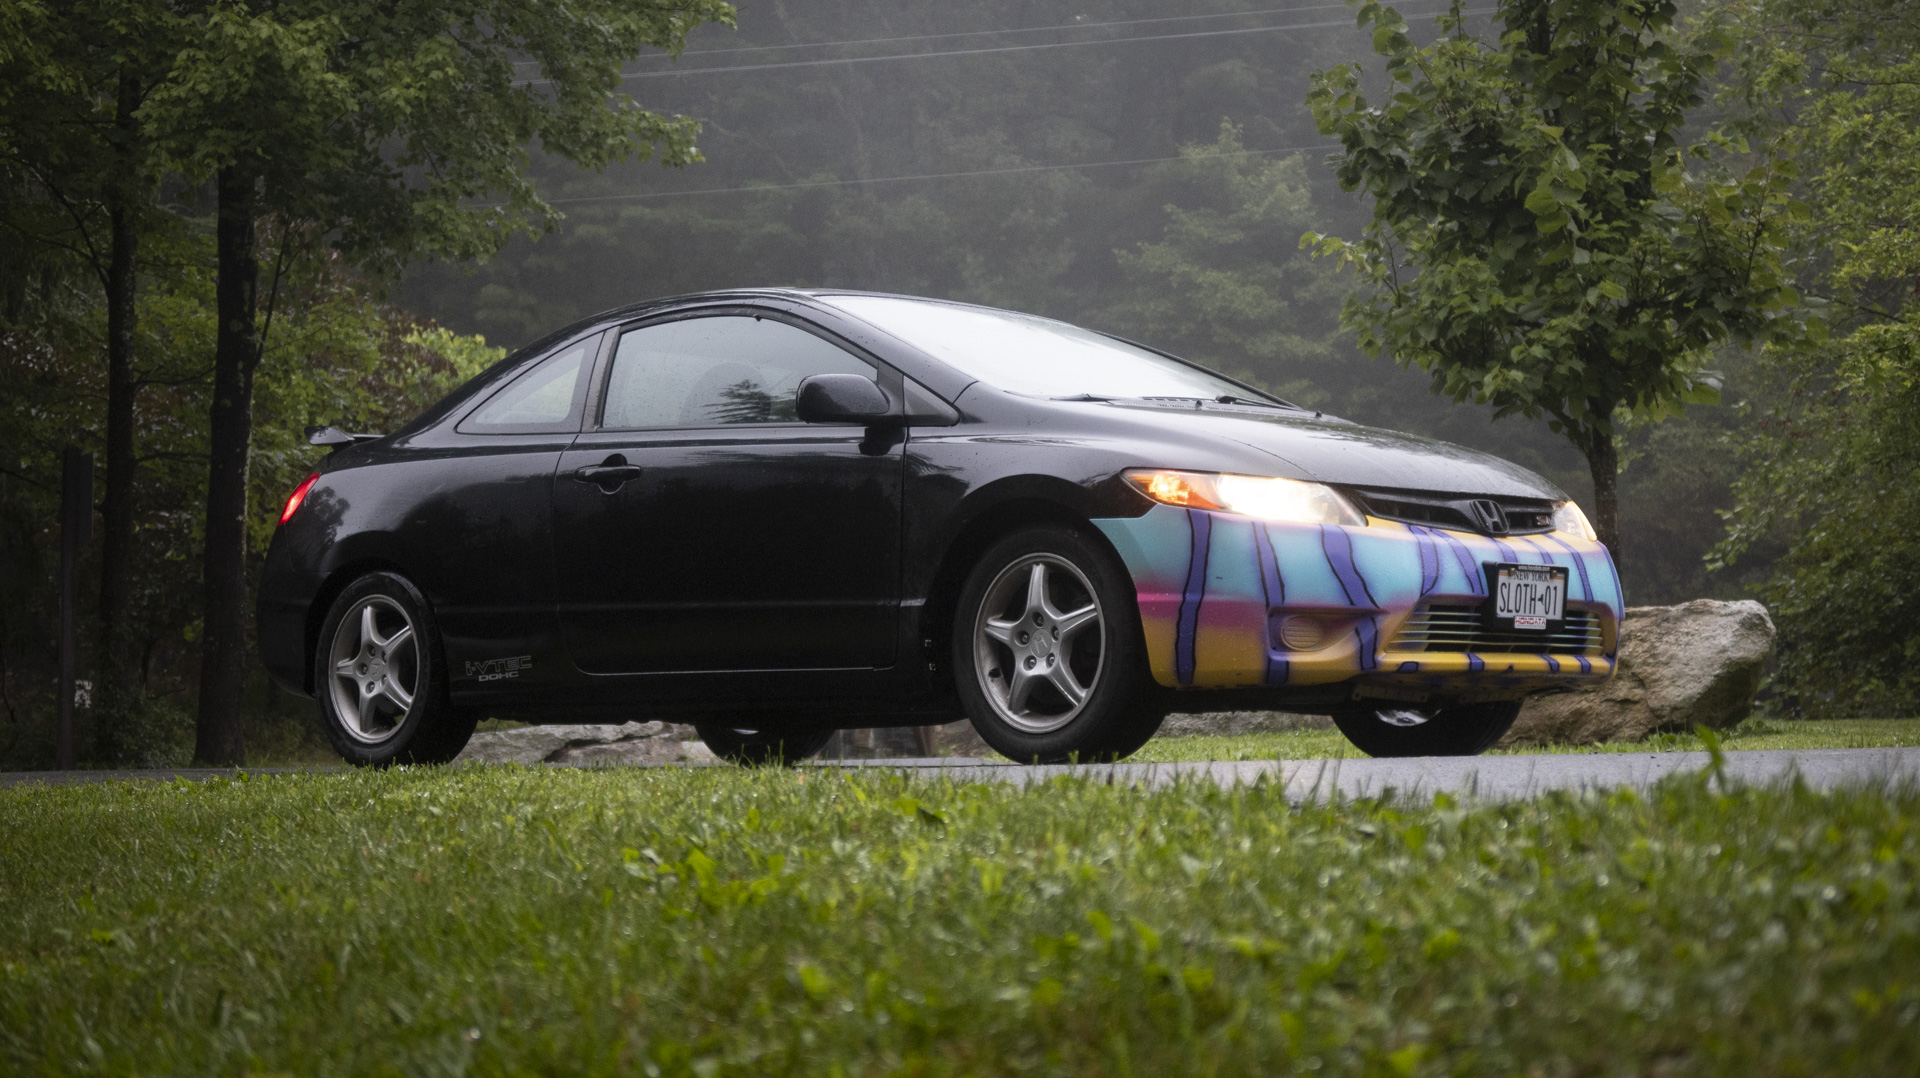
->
xmin=313 ymin=573 xmax=476 ymax=767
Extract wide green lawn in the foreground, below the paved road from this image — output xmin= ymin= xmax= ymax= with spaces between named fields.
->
xmin=0 ymin=767 xmax=1920 ymax=1078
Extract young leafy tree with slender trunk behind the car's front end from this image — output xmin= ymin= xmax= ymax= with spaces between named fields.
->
xmin=1302 ymin=0 xmax=1807 ymax=559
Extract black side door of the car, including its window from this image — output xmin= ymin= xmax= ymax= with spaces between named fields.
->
xmin=553 ymin=311 xmax=902 ymax=674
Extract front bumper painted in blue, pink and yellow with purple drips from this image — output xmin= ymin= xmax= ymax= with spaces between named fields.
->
xmin=1094 ymin=505 xmax=1624 ymax=699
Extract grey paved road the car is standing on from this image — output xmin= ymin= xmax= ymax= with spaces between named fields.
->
xmin=0 ymin=749 xmax=1920 ymax=801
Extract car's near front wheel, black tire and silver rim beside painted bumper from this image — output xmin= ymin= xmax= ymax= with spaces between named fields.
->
xmin=952 ymin=525 xmax=1164 ymax=763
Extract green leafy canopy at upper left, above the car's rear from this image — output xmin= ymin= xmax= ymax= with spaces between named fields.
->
xmin=142 ymin=0 xmax=733 ymax=273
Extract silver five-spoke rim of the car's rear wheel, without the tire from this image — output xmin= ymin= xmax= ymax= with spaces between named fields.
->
xmin=330 ymin=596 xmax=420 ymax=746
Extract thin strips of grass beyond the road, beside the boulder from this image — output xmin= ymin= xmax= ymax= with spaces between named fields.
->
xmin=1127 ymin=719 xmax=1920 ymax=763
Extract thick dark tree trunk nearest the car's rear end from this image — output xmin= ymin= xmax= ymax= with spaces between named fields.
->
xmin=194 ymin=167 xmax=259 ymax=767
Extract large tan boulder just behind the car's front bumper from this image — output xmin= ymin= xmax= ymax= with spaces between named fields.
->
xmin=1501 ymin=600 xmax=1774 ymax=746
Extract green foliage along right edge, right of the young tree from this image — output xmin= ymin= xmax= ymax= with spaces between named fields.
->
xmin=1720 ymin=0 xmax=1920 ymax=715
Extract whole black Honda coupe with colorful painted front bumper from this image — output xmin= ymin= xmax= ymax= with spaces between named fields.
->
xmin=259 ymin=290 xmax=1622 ymax=765
